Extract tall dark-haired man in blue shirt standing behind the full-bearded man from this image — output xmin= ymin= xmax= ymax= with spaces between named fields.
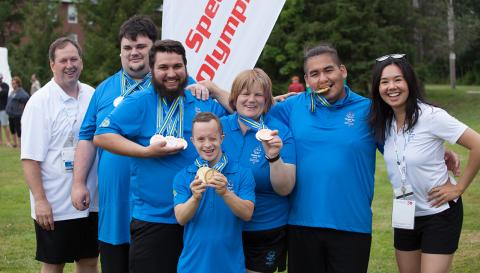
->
xmin=71 ymin=16 xmax=157 ymax=273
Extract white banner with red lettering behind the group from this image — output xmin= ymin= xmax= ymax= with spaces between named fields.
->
xmin=162 ymin=0 xmax=285 ymax=91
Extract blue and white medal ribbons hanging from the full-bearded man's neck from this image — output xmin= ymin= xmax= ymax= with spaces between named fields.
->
xmin=156 ymin=96 xmax=184 ymax=138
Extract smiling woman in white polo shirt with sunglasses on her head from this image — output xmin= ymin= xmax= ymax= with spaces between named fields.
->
xmin=370 ymin=54 xmax=480 ymax=273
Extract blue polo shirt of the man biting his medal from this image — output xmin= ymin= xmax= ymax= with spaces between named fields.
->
xmin=270 ymin=86 xmax=376 ymax=233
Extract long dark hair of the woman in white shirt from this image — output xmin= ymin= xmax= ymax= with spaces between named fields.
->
xmin=369 ymin=57 xmax=428 ymax=144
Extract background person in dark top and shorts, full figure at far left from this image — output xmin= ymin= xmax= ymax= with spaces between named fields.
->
xmin=5 ymin=76 xmax=30 ymax=147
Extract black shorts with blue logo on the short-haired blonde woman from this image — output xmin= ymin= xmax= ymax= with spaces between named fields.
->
xmin=242 ymin=226 xmax=287 ymax=273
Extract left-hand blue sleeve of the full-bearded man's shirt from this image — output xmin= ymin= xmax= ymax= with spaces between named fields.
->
xmin=95 ymin=93 xmax=148 ymax=139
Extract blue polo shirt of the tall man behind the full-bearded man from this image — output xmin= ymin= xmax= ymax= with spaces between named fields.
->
xmin=79 ymin=70 xmax=130 ymax=245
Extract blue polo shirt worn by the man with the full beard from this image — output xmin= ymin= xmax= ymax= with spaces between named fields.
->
xmin=95 ymin=87 xmax=226 ymax=224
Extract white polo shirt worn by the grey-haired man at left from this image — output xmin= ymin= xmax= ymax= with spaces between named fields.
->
xmin=21 ymin=79 xmax=98 ymax=221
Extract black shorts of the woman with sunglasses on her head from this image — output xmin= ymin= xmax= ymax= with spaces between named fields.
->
xmin=394 ymin=198 xmax=463 ymax=254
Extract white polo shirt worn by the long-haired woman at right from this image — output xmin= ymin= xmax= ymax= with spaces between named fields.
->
xmin=383 ymin=103 xmax=468 ymax=216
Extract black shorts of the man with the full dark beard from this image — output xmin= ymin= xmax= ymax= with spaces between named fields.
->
xmin=129 ymin=219 xmax=183 ymax=273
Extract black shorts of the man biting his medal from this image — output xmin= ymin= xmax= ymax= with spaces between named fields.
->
xmin=288 ymin=223 xmax=372 ymax=273
